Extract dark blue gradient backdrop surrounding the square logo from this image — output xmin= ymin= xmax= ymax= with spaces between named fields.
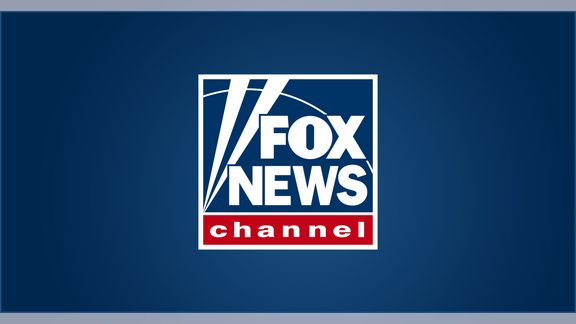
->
xmin=2 ymin=13 xmax=574 ymax=312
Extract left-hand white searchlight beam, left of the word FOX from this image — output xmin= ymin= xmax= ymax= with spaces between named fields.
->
xmin=204 ymin=77 xmax=250 ymax=206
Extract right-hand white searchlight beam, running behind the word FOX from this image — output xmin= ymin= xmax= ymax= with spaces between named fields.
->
xmin=204 ymin=76 xmax=289 ymax=210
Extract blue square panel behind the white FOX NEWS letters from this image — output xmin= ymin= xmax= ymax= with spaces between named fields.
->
xmin=203 ymin=77 xmax=374 ymax=213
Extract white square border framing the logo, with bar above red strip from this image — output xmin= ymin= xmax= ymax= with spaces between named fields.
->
xmin=198 ymin=74 xmax=378 ymax=250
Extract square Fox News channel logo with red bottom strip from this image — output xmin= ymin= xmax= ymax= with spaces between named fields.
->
xmin=198 ymin=74 xmax=378 ymax=250
